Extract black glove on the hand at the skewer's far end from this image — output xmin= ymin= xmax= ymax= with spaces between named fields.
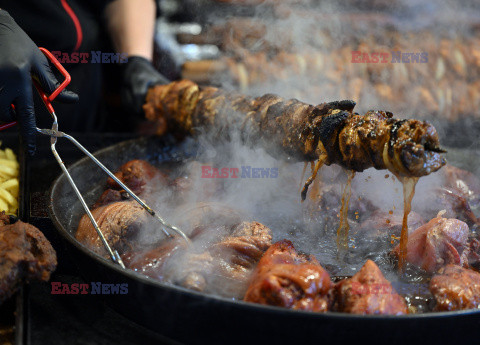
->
xmin=121 ymin=56 xmax=170 ymax=115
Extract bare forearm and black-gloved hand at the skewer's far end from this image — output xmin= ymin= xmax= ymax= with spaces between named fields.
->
xmin=105 ymin=0 xmax=169 ymax=115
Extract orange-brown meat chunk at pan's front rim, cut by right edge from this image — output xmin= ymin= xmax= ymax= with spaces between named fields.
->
xmin=430 ymin=265 xmax=480 ymax=311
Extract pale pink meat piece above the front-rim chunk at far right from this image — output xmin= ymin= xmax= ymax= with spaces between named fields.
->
xmin=393 ymin=214 xmax=470 ymax=273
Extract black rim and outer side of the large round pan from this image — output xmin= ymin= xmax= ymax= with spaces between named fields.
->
xmin=50 ymin=138 xmax=480 ymax=345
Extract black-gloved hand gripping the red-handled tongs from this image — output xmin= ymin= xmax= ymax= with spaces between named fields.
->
xmin=0 ymin=10 xmax=78 ymax=155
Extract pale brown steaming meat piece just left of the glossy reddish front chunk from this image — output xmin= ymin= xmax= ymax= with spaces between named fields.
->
xmin=175 ymin=222 xmax=272 ymax=298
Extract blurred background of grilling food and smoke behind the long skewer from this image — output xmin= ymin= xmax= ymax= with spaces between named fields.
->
xmin=138 ymin=0 xmax=480 ymax=147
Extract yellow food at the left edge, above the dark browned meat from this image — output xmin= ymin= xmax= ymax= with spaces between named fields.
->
xmin=0 ymin=142 xmax=20 ymax=215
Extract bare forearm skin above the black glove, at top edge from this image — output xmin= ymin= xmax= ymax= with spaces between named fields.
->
xmin=106 ymin=0 xmax=156 ymax=61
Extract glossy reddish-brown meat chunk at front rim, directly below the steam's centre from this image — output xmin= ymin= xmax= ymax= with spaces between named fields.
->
xmin=244 ymin=240 xmax=333 ymax=312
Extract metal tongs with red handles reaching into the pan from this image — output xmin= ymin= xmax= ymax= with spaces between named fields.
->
xmin=0 ymin=48 xmax=190 ymax=268
